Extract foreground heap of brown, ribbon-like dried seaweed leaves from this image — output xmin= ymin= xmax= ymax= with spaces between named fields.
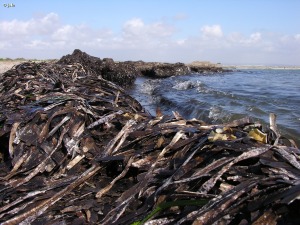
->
xmin=0 ymin=59 xmax=300 ymax=224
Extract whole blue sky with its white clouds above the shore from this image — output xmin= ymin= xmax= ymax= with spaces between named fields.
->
xmin=0 ymin=0 xmax=300 ymax=66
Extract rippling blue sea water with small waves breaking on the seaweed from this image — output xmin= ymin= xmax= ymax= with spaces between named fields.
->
xmin=128 ymin=69 xmax=300 ymax=145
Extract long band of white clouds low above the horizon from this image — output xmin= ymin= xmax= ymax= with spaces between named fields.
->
xmin=0 ymin=13 xmax=300 ymax=65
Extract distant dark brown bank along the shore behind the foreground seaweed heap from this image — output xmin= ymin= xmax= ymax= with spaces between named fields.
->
xmin=57 ymin=49 xmax=227 ymax=86
